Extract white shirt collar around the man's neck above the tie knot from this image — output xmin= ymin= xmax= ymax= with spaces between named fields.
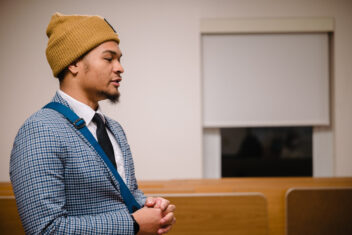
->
xmin=58 ymin=90 xmax=106 ymax=126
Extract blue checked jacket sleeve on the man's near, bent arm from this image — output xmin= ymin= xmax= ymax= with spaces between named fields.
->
xmin=10 ymin=120 xmax=133 ymax=234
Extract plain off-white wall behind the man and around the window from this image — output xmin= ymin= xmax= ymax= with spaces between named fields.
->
xmin=0 ymin=0 xmax=352 ymax=181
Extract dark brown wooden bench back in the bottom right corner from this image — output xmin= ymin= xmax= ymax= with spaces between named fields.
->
xmin=286 ymin=188 xmax=352 ymax=235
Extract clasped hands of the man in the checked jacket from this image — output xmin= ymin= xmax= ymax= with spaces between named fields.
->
xmin=132 ymin=197 xmax=176 ymax=235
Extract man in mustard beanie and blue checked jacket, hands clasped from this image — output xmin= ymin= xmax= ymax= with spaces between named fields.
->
xmin=10 ymin=13 xmax=175 ymax=235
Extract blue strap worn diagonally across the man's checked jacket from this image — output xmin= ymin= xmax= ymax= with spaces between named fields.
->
xmin=43 ymin=102 xmax=141 ymax=213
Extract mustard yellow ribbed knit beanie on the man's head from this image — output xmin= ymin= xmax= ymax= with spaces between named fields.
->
xmin=46 ymin=13 xmax=120 ymax=77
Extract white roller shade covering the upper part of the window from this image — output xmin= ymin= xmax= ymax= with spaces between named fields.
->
xmin=202 ymin=33 xmax=329 ymax=127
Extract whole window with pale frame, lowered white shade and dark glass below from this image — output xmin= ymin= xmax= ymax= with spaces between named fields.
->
xmin=201 ymin=18 xmax=334 ymax=178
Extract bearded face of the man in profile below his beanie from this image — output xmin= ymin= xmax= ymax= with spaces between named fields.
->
xmin=77 ymin=41 xmax=124 ymax=102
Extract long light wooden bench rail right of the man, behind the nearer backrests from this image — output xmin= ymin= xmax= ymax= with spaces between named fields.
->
xmin=139 ymin=177 xmax=352 ymax=235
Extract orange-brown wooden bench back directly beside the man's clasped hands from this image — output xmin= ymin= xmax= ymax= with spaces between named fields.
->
xmin=162 ymin=193 xmax=269 ymax=235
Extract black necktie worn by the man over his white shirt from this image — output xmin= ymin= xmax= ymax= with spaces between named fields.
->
xmin=93 ymin=113 xmax=116 ymax=168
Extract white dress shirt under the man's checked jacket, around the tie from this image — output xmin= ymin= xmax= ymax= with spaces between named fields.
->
xmin=58 ymin=90 xmax=126 ymax=182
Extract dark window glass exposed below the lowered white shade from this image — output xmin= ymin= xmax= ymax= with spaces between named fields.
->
xmin=221 ymin=127 xmax=312 ymax=177
